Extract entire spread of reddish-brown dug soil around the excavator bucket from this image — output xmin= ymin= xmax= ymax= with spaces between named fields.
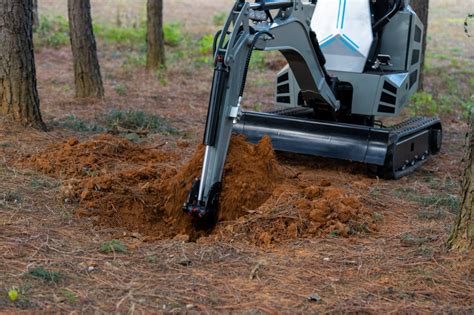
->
xmin=18 ymin=134 xmax=377 ymax=245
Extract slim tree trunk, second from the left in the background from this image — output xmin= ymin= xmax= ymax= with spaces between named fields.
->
xmin=68 ymin=0 xmax=104 ymax=97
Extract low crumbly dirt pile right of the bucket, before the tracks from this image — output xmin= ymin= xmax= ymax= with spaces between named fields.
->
xmin=218 ymin=179 xmax=377 ymax=245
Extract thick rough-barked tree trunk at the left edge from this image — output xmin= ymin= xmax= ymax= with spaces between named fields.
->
xmin=0 ymin=0 xmax=46 ymax=130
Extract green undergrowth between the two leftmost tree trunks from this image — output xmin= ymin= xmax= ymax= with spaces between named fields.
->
xmin=34 ymin=15 xmax=69 ymax=48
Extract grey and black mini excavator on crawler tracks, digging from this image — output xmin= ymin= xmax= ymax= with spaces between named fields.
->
xmin=183 ymin=0 xmax=442 ymax=220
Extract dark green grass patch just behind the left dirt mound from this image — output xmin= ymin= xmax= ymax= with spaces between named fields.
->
xmin=103 ymin=109 xmax=179 ymax=134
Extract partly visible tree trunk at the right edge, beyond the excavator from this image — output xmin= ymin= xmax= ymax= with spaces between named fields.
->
xmin=448 ymin=111 xmax=474 ymax=250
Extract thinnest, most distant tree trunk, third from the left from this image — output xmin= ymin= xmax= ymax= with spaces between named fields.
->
xmin=146 ymin=0 xmax=165 ymax=71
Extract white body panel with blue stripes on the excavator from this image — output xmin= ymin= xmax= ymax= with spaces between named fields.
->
xmin=311 ymin=0 xmax=374 ymax=73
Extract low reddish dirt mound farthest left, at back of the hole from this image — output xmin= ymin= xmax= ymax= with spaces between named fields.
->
xmin=24 ymin=134 xmax=176 ymax=177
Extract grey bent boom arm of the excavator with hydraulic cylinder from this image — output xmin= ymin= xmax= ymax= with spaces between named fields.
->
xmin=183 ymin=0 xmax=340 ymax=218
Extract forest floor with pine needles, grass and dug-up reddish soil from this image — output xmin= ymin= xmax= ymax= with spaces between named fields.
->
xmin=0 ymin=0 xmax=474 ymax=314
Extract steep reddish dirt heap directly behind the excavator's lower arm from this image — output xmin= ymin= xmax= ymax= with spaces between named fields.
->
xmin=165 ymin=136 xmax=282 ymax=221
